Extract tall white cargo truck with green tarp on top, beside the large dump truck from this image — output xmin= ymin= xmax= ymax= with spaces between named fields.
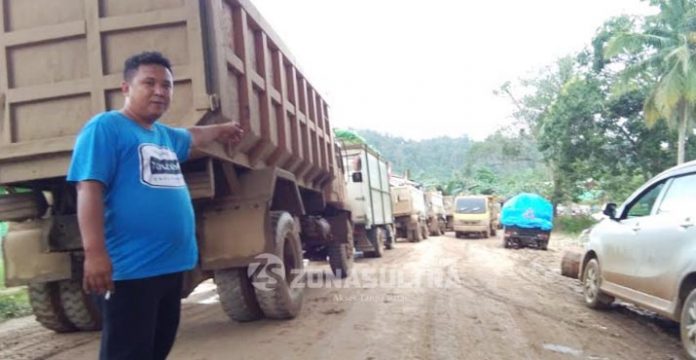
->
xmin=342 ymin=144 xmax=394 ymax=257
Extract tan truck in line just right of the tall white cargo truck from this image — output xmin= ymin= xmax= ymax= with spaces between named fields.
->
xmin=389 ymin=176 xmax=429 ymax=242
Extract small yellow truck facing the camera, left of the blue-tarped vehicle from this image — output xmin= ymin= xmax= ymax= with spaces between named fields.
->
xmin=454 ymin=195 xmax=500 ymax=238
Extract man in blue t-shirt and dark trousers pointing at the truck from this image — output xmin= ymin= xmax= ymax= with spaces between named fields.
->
xmin=68 ymin=52 xmax=243 ymax=359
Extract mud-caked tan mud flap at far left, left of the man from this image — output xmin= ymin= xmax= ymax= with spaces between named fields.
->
xmin=2 ymin=219 xmax=72 ymax=286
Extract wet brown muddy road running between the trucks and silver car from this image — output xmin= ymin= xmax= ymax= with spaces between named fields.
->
xmin=0 ymin=233 xmax=684 ymax=360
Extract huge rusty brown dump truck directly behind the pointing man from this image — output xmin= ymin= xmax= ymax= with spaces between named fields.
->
xmin=0 ymin=0 xmax=353 ymax=332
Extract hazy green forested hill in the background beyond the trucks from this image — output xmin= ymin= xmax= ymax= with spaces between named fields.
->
xmin=346 ymin=130 xmax=548 ymax=195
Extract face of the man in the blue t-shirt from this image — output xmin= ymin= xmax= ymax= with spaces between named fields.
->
xmin=121 ymin=64 xmax=174 ymax=124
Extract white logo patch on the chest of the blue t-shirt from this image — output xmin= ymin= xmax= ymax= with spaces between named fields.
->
xmin=138 ymin=144 xmax=186 ymax=188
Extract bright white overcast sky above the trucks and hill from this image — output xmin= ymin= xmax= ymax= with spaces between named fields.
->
xmin=251 ymin=0 xmax=654 ymax=140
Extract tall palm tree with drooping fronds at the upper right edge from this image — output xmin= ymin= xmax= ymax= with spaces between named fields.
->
xmin=605 ymin=0 xmax=696 ymax=164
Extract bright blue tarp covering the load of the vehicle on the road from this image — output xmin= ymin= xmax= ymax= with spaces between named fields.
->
xmin=500 ymin=193 xmax=553 ymax=231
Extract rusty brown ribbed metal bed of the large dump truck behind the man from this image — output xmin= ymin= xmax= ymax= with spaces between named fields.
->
xmin=0 ymin=0 xmax=335 ymax=190
